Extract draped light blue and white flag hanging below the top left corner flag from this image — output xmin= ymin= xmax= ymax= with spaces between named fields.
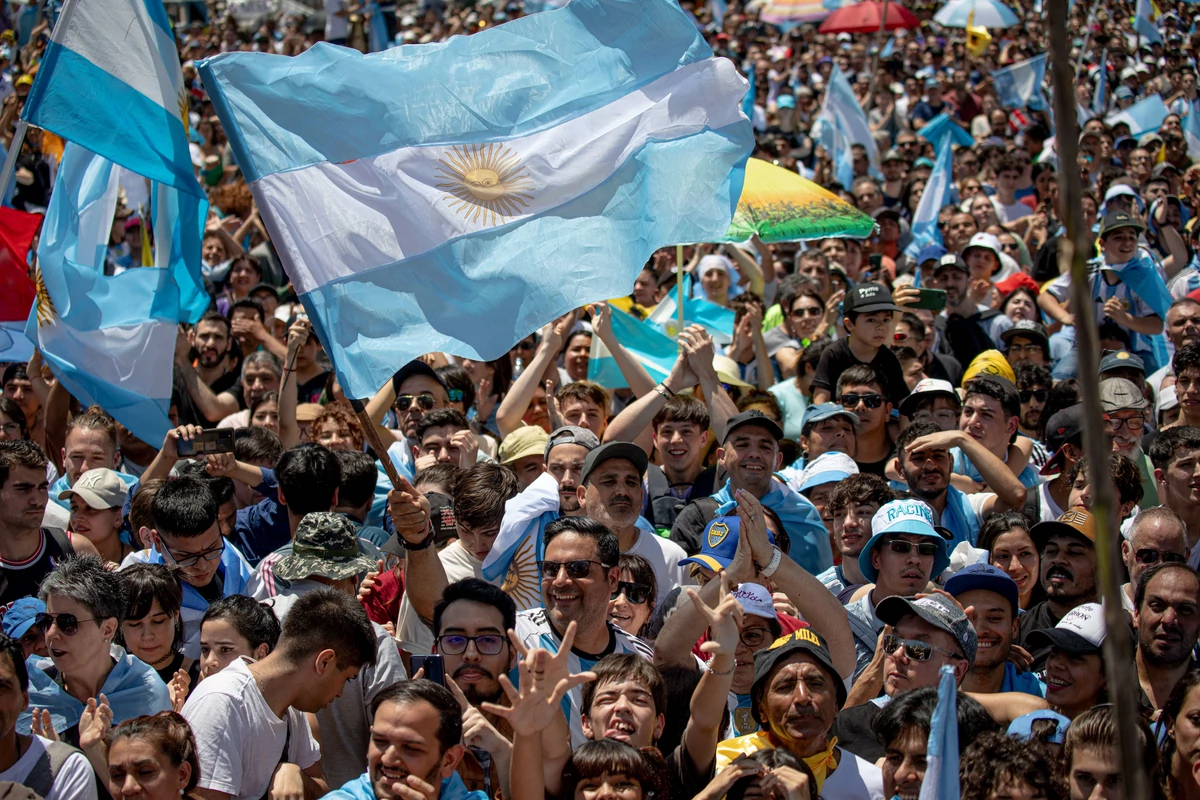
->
xmin=25 ymin=143 xmax=209 ymax=443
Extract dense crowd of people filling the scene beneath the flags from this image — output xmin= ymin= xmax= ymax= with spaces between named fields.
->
xmin=0 ymin=0 xmax=1200 ymax=800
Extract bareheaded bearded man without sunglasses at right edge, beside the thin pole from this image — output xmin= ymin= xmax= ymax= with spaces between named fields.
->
xmin=1133 ymin=561 xmax=1200 ymax=714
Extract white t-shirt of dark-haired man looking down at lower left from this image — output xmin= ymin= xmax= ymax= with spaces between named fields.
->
xmin=184 ymin=658 xmax=320 ymax=800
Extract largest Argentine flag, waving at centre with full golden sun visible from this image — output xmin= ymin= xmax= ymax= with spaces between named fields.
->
xmin=199 ymin=0 xmax=752 ymax=397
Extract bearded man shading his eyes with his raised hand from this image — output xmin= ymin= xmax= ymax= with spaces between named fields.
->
xmin=894 ymin=422 xmax=1025 ymax=547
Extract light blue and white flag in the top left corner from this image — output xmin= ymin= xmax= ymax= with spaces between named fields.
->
xmin=23 ymin=0 xmax=203 ymax=197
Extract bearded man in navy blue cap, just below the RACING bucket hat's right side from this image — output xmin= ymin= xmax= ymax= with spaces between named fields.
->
xmin=946 ymin=564 xmax=1046 ymax=697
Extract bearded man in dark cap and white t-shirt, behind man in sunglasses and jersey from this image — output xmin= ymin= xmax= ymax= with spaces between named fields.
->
xmin=578 ymin=441 xmax=691 ymax=596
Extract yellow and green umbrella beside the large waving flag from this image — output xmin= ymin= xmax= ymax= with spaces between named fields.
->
xmin=725 ymin=158 xmax=875 ymax=242
